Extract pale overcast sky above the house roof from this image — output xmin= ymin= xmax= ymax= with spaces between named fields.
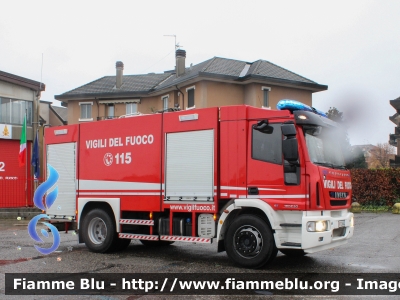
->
xmin=0 ymin=0 xmax=400 ymax=145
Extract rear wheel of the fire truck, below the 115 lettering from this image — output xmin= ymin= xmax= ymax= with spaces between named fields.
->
xmin=82 ymin=208 xmax=118 ymax=253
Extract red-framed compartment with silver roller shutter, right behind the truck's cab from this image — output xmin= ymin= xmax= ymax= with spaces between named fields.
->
xmin=162 ymin=107 xmax=219 ymax=212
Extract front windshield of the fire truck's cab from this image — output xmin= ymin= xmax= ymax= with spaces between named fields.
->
xmin=304 ymin=126 xmax=346 ymax=169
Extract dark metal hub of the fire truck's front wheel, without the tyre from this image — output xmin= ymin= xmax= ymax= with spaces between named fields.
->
xmin=234 ymin=226 xmax=262 ymax=258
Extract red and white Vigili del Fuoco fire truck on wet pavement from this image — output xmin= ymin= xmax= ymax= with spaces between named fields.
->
xmin=45 ymin=106 xmax=354 ymax=268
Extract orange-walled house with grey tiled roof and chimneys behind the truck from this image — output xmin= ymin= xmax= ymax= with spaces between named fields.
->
xmin=55 ymin=49 xmax=328 ymax=124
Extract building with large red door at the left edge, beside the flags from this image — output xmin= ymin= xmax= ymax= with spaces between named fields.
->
xmin=0 ymin=71 xmax=45 ymax=207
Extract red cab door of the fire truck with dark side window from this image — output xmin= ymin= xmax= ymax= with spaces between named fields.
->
xmin=247 ymin=121 xmax=307 ymax=210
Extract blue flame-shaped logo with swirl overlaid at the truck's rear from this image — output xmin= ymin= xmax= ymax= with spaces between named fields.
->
xmin=28 ymin=164 xmax=60 ymax=254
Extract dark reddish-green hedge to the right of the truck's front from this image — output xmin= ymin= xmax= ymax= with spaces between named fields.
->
xmin=351 ymin=169 xmax=400 ymax=206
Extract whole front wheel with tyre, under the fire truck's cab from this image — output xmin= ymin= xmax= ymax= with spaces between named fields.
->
xmin=224 ymin=215 xmax=277 ymax=268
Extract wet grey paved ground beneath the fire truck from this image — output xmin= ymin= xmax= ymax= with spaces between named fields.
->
xmin=0 ymin=213 xmax=400 ymax=299
